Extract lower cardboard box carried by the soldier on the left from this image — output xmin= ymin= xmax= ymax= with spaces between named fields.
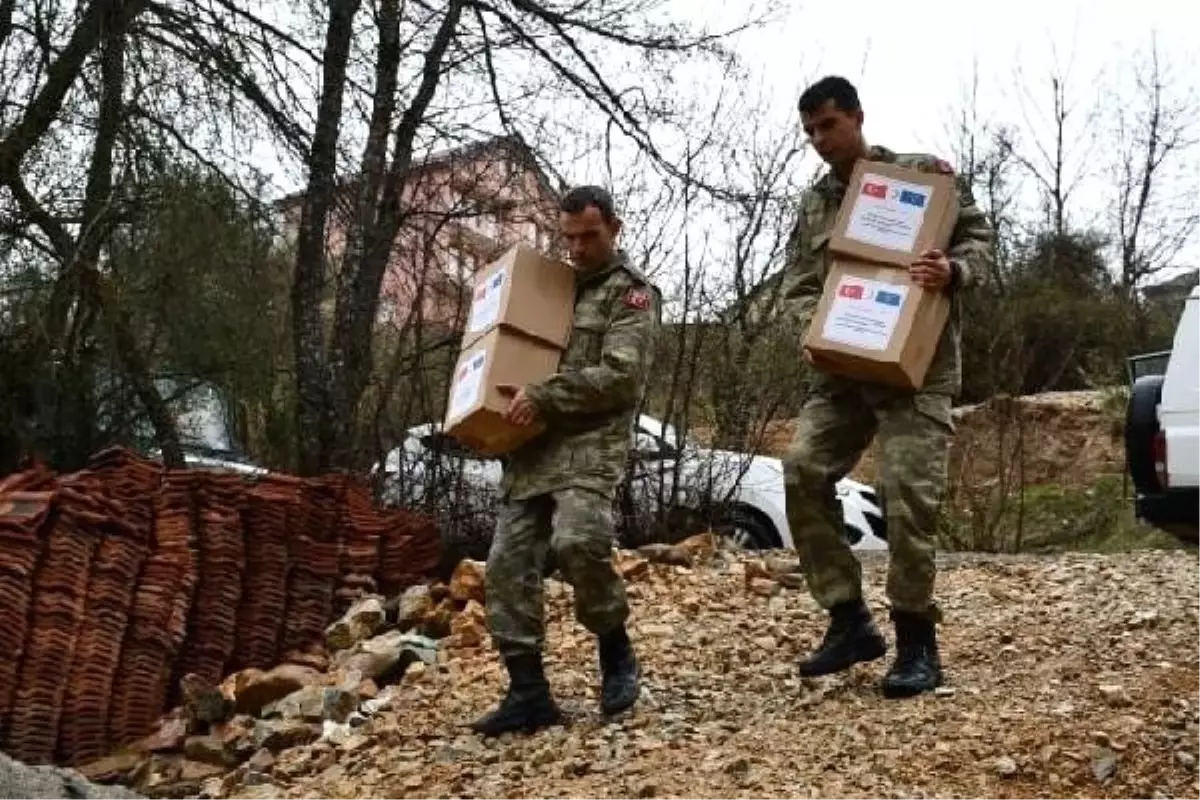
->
xmin=443 ymin=327 xmax=562 ymax=456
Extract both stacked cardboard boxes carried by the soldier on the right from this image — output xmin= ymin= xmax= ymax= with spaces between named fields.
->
xmin=804 ymin=161 xmax=959 ymax=389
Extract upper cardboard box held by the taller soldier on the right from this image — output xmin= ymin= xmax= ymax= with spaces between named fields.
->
xmin=829 ymin=160 xmax=959 ymax=266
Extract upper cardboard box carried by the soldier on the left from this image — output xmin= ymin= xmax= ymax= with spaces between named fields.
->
xmin=463 ymin=243 xmax=575 ymax=348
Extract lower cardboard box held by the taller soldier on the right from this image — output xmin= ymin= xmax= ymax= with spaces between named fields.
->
xmin=804 ymin=259 xmax=950 ymax=390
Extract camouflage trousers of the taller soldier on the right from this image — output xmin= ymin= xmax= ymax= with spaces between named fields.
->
xmin=784 ymin=386 xmax=954 ymax=619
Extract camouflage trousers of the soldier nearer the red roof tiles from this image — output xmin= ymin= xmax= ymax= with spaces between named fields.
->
xmin=486 ymin=489 xmax=629 ymax=657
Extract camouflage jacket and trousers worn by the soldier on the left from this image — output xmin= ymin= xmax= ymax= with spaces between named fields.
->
xmin=486 ymin=252 xmax=660 ymax=657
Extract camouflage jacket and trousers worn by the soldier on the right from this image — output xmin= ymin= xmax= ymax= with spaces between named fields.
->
xmin=782 ymin=146 xmax=991 ymax=619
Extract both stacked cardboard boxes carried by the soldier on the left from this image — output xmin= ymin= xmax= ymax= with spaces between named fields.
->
xmin=443 ymin=243 xmax=575 ymax=456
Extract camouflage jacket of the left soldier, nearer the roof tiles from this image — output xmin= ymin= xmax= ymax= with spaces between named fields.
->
xmin=502 ymin=251 xmax=661 ymax=500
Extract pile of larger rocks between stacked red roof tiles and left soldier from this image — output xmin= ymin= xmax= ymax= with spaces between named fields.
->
xmin=72 ymin=561 xmax=486 ymax=798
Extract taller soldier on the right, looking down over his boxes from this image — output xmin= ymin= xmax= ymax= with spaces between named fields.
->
xmin=782 ymin=77 xmax=991 ymax=697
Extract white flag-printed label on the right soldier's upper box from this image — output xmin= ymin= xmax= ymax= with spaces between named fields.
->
xmin=846 ymin=174 xmax=934 ymax=253
